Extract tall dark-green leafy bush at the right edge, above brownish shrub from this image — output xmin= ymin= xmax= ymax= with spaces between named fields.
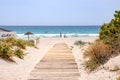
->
xmin=99 ymin=11 xmax=120 ymax=54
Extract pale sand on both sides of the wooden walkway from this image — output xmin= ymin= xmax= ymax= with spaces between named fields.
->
xmin=0 ymin=37 xmax=116 ymax=80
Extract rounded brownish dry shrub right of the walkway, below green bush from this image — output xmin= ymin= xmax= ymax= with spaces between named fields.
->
xmin=84 ymin=40 xmax=111 ymax=71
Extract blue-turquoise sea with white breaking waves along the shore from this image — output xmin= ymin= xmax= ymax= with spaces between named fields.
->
xmin=0 ymin=25 xmax=100 ymax=38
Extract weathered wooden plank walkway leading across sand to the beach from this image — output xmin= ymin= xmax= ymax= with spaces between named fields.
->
xmin=28 ymin=43 xmax=80 ymax=80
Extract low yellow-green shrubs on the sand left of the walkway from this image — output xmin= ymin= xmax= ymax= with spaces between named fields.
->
xmin=0 ymin=37 xmax=35 ymax=61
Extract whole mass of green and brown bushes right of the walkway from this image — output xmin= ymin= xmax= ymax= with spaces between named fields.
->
xmin=84 ymin=11 xmax=120 ymax=72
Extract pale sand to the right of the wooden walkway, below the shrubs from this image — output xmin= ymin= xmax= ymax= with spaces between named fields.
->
xmin=72 ymin=39 xmax=120 ymax=80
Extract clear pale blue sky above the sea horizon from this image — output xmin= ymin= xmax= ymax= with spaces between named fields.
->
xmin=0 ymin=0 xmax=120 ymax=25
